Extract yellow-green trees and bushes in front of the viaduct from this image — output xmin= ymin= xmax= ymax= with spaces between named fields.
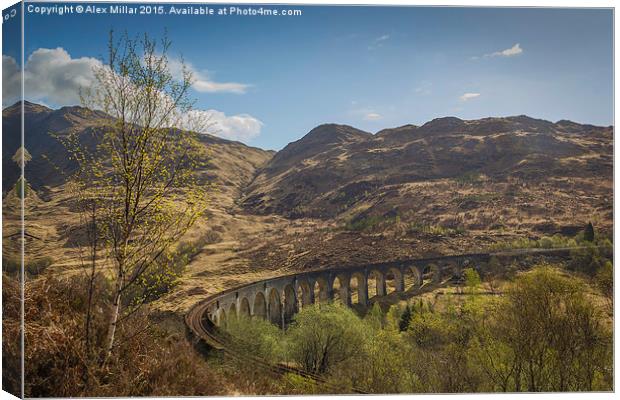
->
xmin=222 ymin=265 xmax=613 ymax=393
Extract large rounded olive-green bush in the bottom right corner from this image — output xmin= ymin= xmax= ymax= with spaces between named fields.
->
xmin=495 ymin=266 xmax=613 ymax=392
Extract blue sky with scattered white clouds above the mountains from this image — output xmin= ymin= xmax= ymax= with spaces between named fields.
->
xmin=3 ymin=3 xmax=613 ymax=150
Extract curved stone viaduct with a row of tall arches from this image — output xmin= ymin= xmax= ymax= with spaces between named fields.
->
xmin=205 ymin=254 xmax=496 ymax=327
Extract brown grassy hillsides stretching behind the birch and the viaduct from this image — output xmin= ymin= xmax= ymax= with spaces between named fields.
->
xmin=3 ymin=103 xmax=613 ymax=313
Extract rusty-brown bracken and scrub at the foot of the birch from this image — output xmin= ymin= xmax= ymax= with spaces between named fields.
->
xmin=3 ymin=275 xmax=224 ymax=397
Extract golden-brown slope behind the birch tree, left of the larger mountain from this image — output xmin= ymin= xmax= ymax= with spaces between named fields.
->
xmin=2 ymin=102 xmax=273 ymax=282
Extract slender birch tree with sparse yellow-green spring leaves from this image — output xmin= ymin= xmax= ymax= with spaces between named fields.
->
xmin=64 ymin=33 xmax=210 ymax=364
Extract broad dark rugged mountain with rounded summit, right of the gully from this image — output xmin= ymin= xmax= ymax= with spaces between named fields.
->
xmin=242 ymin=115 xmax=613 ymax=225
